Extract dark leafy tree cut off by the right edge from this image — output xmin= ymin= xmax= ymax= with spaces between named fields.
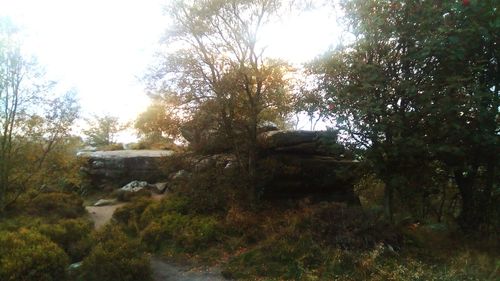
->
xmin=425 ymin=1 xmax=500 ymax=231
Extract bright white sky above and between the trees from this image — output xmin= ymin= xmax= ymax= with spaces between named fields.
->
xmin=0 ymin=0 xmax=339 ymax=139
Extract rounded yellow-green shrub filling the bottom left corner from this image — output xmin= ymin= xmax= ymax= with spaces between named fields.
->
xmin=0 ymin=228 xmax=68 ymax=281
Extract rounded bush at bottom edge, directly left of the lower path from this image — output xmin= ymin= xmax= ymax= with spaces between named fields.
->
xmin=81 ymin=226 xmax=152 ymax=281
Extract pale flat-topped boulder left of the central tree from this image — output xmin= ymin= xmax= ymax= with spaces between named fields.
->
xmin=78 ymin=150 xmax=174 ymax=186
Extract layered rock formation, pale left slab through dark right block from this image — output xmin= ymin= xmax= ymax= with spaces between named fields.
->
xmin=81 ymin=130 xmax=358 ymax=203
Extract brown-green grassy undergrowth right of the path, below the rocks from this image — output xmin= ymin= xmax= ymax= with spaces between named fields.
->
xmin=115 ymin=187 xmax=500 ymax=281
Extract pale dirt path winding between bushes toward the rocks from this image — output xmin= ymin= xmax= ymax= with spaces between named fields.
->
xmin=85 ymin=199 xmax=226 ymax=281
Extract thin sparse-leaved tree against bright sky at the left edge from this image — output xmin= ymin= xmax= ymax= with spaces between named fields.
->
xmin=0 ymin=19 xmax=79 ymax=212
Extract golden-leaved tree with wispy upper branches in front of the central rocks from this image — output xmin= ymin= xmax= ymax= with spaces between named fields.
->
xmin=149 ymin=0 xmax=290 ymax=178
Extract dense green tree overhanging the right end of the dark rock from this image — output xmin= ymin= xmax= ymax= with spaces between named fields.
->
xmin=312 ymin=1 xmax=444 ymax=219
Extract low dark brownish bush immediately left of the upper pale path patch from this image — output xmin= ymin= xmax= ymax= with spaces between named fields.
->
xmin=24 ymin=192 xmax=85 ymax=218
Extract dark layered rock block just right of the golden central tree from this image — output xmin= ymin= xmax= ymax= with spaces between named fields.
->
xmin=258 ymin=131 xmax=359 ymax=203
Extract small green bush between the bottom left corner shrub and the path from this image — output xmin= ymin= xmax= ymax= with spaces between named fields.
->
xmin=38 ymin=218 xmax=93 ymax=262
